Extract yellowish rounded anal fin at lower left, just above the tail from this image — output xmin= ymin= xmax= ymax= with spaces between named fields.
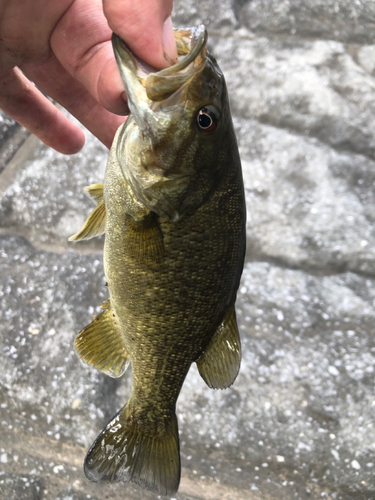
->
xmin=75 ymin=301 xmax=129 ymax=378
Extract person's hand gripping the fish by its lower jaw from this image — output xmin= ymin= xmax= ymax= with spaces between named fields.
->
xmin=0 ymin=0 xmax=177 ymax=154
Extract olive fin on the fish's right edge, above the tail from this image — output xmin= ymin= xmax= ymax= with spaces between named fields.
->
xmin=197 ymin=306 xmax=241 ymax=389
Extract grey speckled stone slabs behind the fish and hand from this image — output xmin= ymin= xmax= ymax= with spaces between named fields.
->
xmin=0 ymin=0 xmax=375 ymax=500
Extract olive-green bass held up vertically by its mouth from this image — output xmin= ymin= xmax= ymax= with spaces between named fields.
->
xmin=70 ymin=25 xmax=246 ymax=495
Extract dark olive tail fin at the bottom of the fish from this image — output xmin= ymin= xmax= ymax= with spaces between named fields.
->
xmin=85 ymin=406 xmax=181 ymax=495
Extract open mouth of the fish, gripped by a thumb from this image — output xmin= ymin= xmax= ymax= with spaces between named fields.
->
xmin=112 ymin=25 xmax=207 ymax=130
